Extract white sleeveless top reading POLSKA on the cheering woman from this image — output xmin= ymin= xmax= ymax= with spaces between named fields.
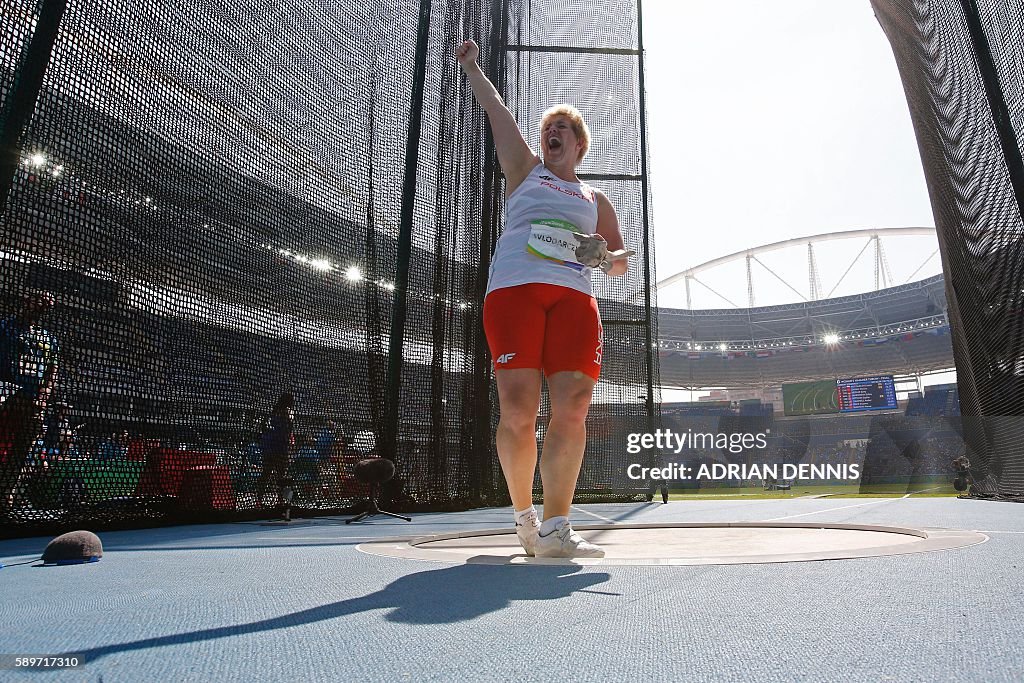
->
xmin=487 ymin=164 xmax=597 ymax=296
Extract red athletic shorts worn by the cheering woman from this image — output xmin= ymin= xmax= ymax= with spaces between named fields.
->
xmin=483 ymin=283 xmax=603 ymax=382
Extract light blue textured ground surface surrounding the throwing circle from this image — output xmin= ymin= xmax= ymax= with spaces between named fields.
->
xmin=0 ymin=498 xmax=1024 ymax=683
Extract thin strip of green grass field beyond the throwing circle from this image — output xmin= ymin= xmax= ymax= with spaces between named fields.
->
xmin=667 ymin=481 xmax=957 ymax=501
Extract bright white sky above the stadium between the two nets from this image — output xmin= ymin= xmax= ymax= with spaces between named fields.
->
xmin=643 ymin=0 xmax=941 ymax=307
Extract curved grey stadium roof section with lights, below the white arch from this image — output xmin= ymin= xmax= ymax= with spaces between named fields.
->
xmin=658 ymin=275 xmax=953 ymax=388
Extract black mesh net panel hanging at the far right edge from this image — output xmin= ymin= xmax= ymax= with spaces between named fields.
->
xmin=872 ymin=0 xmax=1024 ymax=500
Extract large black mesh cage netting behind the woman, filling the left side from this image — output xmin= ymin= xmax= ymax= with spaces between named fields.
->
xmin=0 ymin=0 xmax=657 ymax=532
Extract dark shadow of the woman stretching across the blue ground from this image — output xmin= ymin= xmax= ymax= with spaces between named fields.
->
xmin=68 ymin=564 xmax=616 ymax=661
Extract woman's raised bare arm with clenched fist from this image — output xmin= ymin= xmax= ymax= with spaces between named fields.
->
xmin=456 ymin=40 xmax=541 ymax=194
